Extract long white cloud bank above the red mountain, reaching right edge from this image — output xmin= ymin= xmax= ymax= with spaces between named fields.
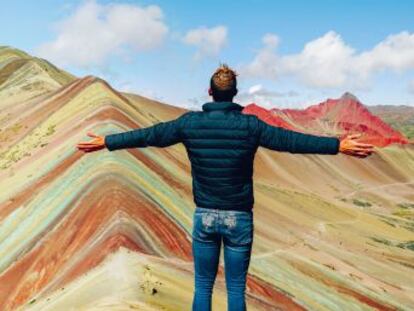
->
xmin=240 ymin=31 xmax=414 ymax=88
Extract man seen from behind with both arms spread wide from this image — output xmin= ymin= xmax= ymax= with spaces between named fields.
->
xmin=77 ymin=65 xmax=373 ymax=311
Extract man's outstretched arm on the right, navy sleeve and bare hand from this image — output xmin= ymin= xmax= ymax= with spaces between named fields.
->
xmin=258 ymin=119 xmax=373 ymax=157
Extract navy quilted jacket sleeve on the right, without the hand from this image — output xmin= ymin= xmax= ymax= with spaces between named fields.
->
xmin=257 ymin=118 xmax=340 ymax=154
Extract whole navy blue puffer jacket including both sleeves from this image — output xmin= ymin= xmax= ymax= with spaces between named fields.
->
xmin=105 ymin=102 xmax=340 ymax=211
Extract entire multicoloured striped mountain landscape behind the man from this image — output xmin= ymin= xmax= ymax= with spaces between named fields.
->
xmin=0 ymin=47 xmax=414 ymax=311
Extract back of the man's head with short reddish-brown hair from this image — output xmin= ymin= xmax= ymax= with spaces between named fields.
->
xmin=208 ymin=64 xmax=237 ymax=102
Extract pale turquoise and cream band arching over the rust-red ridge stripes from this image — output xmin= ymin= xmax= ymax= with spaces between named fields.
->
xmin=0 ymin=152 xmax=192 ymax=271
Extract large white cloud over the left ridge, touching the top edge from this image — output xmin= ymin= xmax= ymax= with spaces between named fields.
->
xmin=35 ymin=0 xmax=168 ymax=68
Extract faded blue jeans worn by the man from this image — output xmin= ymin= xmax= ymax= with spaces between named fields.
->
xmin=192 ymin=206 xmax=254 ymax=311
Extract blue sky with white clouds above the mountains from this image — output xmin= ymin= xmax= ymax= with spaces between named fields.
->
xmin=0 ymin=0 xmax=414 ymax=109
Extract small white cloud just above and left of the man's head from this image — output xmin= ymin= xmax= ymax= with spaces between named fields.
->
xmin=182 ymin=25 xmax=228 ymax=60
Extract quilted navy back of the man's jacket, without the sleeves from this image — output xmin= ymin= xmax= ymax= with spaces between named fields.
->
xmin=181 ymin=102 xmax=258 ymax=210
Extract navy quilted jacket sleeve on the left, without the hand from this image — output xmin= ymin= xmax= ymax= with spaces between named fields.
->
xmin=105 ymin=113 xmax=187 ymax=151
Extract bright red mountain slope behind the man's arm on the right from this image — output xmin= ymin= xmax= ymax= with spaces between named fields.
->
xmin=243 ymin=93 xmax=409 ymax=147
